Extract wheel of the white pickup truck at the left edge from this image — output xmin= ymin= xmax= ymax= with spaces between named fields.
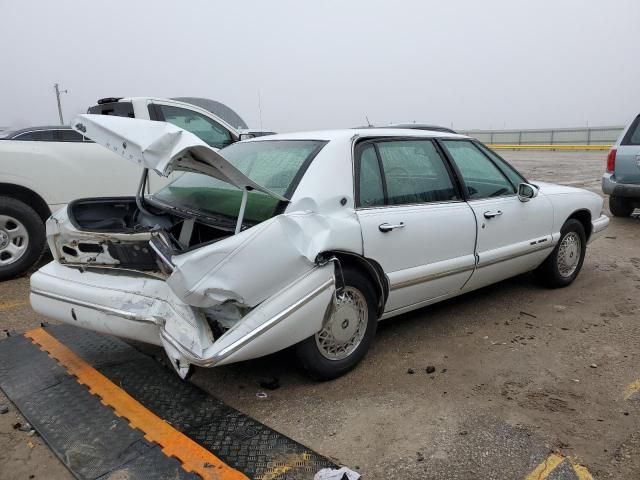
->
xmin=0 ymin=197 xmax=45 ymax=280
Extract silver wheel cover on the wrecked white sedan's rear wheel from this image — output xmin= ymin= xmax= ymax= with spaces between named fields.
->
xmin=316 ymin=287 xmax=369 ymax=360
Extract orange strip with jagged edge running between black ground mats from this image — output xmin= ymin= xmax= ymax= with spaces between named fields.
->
xmin=25 ymin=328 xmax=249 ymax=480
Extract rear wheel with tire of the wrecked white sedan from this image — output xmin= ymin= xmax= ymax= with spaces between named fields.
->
xmin=296 ymin=266 xmax=378 ymax=380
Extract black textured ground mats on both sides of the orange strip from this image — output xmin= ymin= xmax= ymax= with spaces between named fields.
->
xmin=0 ymin=325 xmax=335 ymax=480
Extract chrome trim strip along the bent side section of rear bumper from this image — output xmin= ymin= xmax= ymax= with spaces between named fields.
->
xmin=160 ymin=277 xmax=335 ymax=367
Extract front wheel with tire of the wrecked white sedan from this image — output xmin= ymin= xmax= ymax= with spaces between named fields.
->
xmin=536 ymin=218 xmax=587 ymax=288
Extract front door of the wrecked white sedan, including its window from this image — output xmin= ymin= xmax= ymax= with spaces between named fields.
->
xmin=441 ymin=140 xmax=553 ymax=290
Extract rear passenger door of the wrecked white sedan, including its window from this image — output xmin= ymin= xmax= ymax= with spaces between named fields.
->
xmin=355 ymin=138 xmax=476 ymax=317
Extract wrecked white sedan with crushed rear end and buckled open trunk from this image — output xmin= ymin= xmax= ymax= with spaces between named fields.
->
xmin=31 ymin=115 xmax=609 ymax=379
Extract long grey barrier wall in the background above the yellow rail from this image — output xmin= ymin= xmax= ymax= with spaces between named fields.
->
xmin=460 ymin=126 xmax=624 ymax=148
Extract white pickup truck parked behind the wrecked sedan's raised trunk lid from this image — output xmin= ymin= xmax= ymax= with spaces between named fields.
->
xmin=0 ymin=97 xmax=241 ymax=280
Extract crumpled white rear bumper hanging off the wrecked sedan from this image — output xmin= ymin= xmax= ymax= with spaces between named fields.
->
xmin=31 ymin=261 xmax=335 ymax=366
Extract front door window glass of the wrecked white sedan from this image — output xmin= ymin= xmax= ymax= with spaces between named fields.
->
xmin=442 ymin=140 xmax=516 ymax=200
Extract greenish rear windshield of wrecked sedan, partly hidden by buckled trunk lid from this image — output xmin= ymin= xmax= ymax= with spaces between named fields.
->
xmin=152 ymin=140 xmax=326 ymax=223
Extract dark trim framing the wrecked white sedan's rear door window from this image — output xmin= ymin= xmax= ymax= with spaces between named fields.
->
xmin=353 ymin=137 xmax=466 ymax=210
